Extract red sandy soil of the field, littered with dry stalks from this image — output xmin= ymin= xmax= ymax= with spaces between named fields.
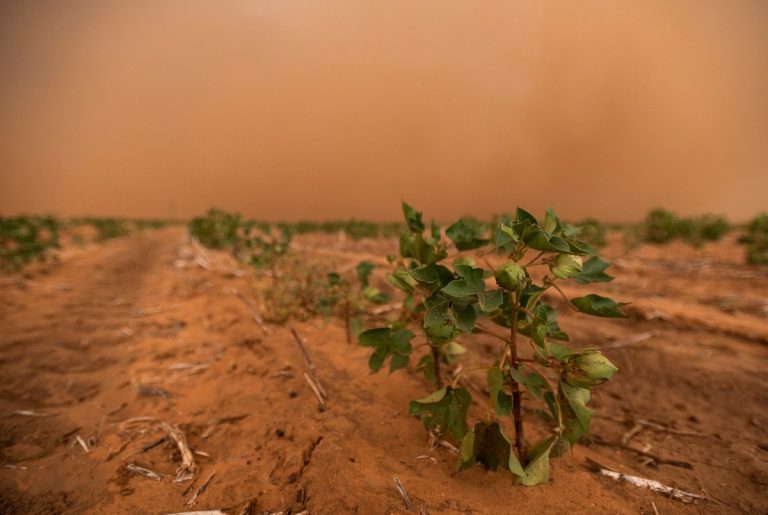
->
xmin=0 ymin=228 xmax=768 ymax=514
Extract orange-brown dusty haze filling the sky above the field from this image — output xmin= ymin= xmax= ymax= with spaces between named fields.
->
xmin=0 ymin=0 xmax=768 ymax=220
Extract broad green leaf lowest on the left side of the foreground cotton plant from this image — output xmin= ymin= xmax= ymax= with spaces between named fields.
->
xmin=408 ymin=386 xmax=472 ymax=440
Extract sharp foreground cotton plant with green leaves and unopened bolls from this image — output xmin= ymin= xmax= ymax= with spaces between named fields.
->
xmin=359 ymin=203 xmax=625 ymax=485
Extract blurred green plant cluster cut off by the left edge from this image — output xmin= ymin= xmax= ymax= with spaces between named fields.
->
xmin=0 ymin=216 xmax=62 ymax=271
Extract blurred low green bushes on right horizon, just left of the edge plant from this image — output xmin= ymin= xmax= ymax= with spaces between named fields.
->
xmin=637 ymin=209 xmax=731 ymax=247
